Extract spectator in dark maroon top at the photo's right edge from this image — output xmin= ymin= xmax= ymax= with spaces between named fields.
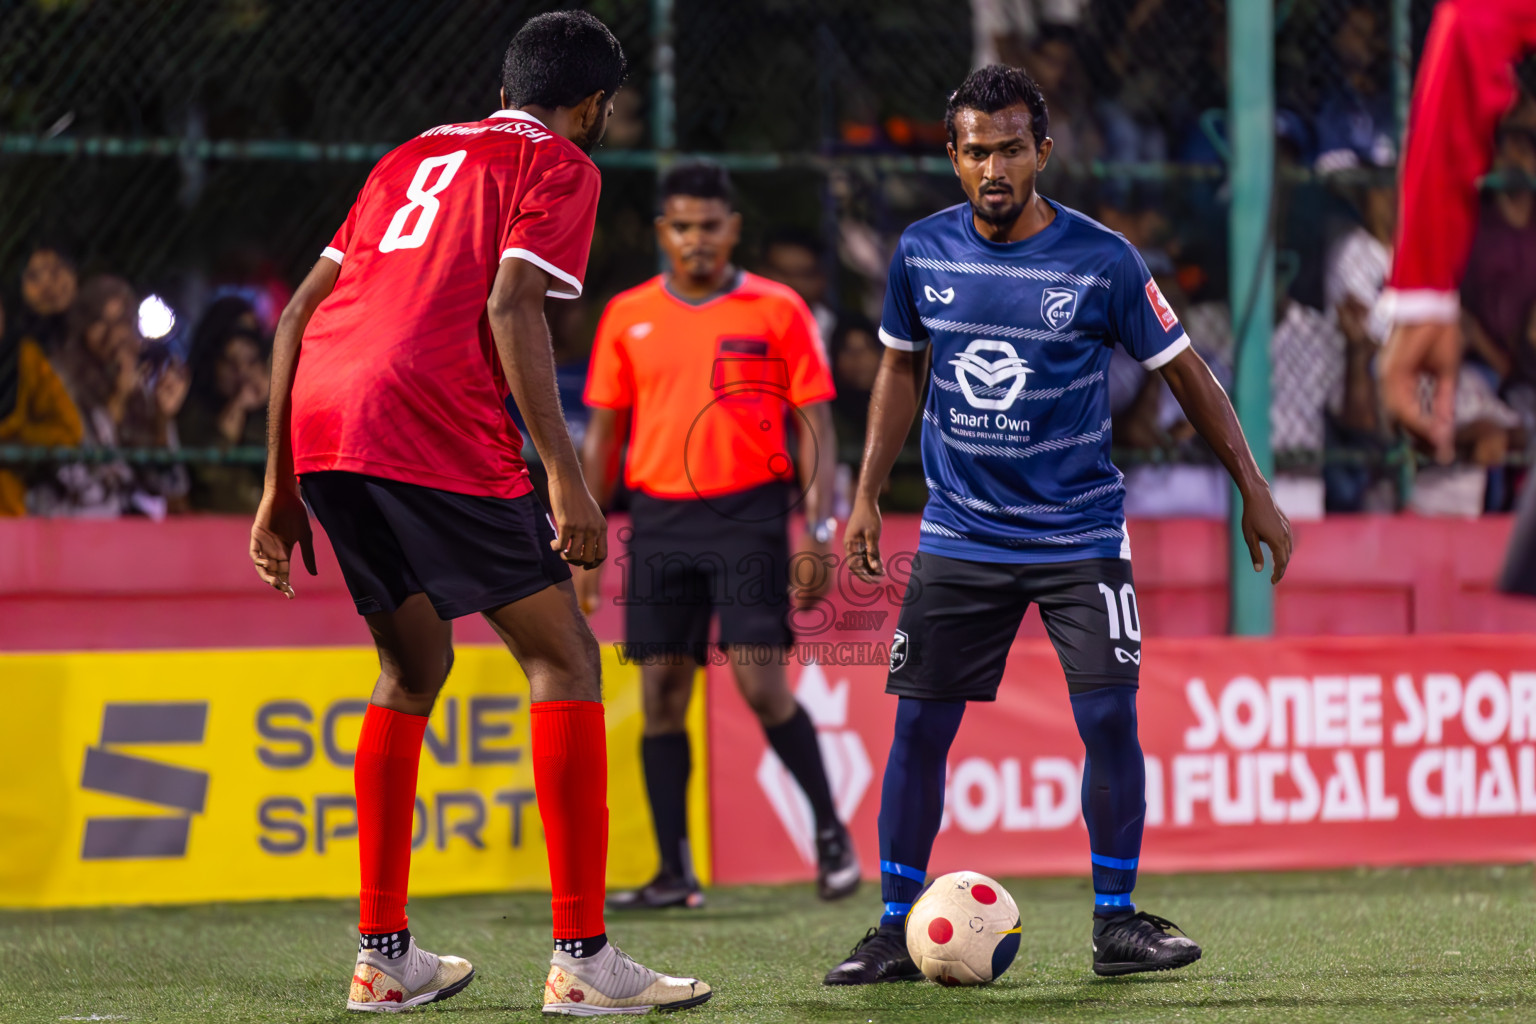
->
xmin=1461 ymin=124 xmax=1536 ymax=408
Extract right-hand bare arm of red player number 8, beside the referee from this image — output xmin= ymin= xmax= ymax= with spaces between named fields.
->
xmin=485 ymin=258 xmax=608 ymax=568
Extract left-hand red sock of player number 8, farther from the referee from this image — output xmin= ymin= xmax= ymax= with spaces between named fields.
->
xmin=352 ymin=705 xmax=427 ymax=935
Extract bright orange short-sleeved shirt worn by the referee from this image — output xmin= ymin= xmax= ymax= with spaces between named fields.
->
xmin=585 ymin=273 xmax=834 ymax=499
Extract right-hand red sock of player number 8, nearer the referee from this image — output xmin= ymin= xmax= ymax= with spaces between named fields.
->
xmin=530 ymin=700 xmax=608 ymax=940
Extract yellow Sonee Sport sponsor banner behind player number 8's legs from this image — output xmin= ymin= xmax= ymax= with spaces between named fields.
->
xmin=0 ymin=646 xmax=710 ymax=907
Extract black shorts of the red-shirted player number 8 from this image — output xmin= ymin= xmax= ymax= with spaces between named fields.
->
xmin=300 ymin=471 xmax=571 ymax=619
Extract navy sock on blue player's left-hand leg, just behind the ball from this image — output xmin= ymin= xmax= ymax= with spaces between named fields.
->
xmin=880 ymin=697 xmax=965 ymax=927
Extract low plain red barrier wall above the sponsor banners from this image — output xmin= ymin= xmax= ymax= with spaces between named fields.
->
xmin=0 ymin=516 xmax=1536 ymax=649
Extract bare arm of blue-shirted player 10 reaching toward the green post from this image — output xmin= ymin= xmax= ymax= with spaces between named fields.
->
xmin=1161 ymin=348 xmax=1292 ymax=583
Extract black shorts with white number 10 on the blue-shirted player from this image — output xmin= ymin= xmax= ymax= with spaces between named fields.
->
xmin=885 ymin=551 xmax=1141 ymax=700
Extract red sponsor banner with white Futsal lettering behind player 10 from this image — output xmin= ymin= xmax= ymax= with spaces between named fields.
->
xmin=710 ymin=632 xmax=1536 ymax=883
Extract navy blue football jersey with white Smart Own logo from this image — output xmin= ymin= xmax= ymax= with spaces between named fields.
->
xmin=880 ymin=203 xmax=1189 ymax=562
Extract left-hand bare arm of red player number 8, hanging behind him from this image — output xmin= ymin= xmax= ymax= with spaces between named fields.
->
xmin=250 ymin=256 xmax=341 ymax=599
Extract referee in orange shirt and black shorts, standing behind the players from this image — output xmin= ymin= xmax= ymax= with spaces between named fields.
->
xmin=578 ymin=163 xmax=859 ymax=909
